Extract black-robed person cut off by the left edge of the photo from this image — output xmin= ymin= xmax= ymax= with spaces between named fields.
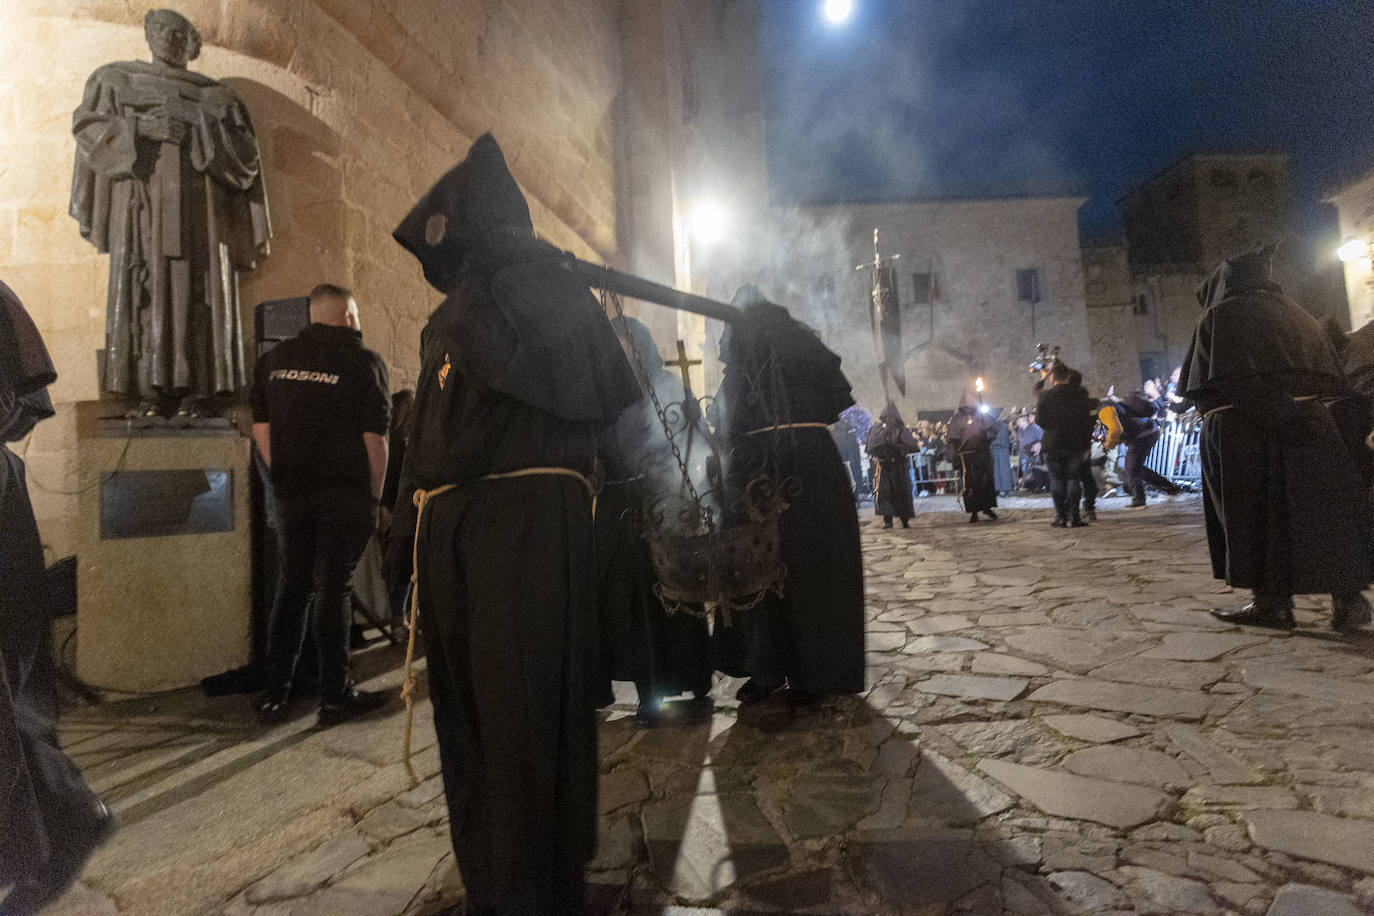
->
xmin=0 ymin=283 xmax=113 ymax=913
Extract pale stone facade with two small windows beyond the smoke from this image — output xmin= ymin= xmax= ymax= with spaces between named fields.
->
xmin=794 ymin=198 xmax=1096 ymax=420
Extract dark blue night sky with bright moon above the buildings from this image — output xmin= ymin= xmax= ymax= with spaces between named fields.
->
xmin=761 ymin=0 xmax=1374 ymax=247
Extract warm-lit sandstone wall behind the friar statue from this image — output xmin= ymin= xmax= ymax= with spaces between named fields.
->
xmin=0 ymin=0 xmax=621 ymax=556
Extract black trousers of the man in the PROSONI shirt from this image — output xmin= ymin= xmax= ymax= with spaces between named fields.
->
xmin=265 ymin=490 xmax=376 ymax=700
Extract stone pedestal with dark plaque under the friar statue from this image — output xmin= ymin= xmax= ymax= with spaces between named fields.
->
xmin=77 ymin=401 xmax=253 ymax=691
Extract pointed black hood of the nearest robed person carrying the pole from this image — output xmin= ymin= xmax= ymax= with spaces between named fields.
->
xmin=392 ymin=133 xmax=534 ymax=294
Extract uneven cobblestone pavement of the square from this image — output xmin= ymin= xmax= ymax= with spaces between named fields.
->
xmin=29 ymin=497 xmax=1374 ymax=916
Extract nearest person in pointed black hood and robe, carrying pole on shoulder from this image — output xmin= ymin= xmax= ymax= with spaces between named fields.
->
xmin=394 ymin=135 xmax=640 ymax=913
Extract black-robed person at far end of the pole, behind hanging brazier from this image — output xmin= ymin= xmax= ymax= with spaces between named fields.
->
xmin=712 ymin=286 xmax=864 ymax=702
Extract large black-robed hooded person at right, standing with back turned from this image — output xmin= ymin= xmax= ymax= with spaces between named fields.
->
xmin=1179 ymin=247 xmax=1374 ymax=629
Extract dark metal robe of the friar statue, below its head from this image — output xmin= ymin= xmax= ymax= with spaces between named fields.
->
xmin=70 ymin=60 xmax=272 ymax=397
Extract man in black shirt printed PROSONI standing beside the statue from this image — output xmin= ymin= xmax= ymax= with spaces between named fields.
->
xmin=253 ymin=283 xmax=392 ymax=725
